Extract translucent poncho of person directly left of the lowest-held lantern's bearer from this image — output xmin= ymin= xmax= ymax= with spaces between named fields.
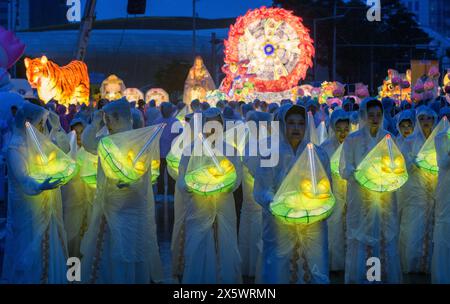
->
xmin=177 ymin=108 xmax=241 ymax=283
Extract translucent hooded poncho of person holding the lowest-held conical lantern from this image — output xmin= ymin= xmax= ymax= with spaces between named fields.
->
xmin=253 ymin=105 xmax=330 ymax=284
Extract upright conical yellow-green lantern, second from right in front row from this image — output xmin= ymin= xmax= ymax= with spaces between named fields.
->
xmin=355 ymin=135 xmax=408 ymax=192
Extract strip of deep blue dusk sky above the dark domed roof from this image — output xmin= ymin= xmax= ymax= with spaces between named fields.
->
xmin=91 ymin=0 xmax=272 ymax=19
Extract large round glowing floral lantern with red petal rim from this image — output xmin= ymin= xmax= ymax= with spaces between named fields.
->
xmin=224 ymin=7 xmax=314 ymax=100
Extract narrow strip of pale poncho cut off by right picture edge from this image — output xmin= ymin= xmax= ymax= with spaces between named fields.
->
xmin=431 ymin=129 xmax=450 ymax=284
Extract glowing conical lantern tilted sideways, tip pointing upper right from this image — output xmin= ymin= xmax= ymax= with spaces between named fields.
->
xmin=98 ymin=124 xmax=164 ymax=183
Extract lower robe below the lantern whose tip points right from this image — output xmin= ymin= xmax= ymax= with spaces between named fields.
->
xmin=81 ymin=160 xmax=164 ymax=284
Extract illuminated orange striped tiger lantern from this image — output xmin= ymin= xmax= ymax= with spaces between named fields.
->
xmin=25 ymin=56 xmax=89 ymax=106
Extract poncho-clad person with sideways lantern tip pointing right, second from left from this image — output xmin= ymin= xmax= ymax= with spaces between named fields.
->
xmin=81 ymin=100 xmax=163 ymax=283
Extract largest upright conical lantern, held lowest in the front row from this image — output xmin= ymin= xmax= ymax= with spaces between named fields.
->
xmin=270 ymin=143 xmax=335 ymax=224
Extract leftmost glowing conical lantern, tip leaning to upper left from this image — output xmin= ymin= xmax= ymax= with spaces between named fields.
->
xmin=25 ymin=122 xmax=78 ymax=185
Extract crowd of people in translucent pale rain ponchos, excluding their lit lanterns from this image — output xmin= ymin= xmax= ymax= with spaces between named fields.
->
xmin=0 ymin=88 xmax=450 ymax=283
